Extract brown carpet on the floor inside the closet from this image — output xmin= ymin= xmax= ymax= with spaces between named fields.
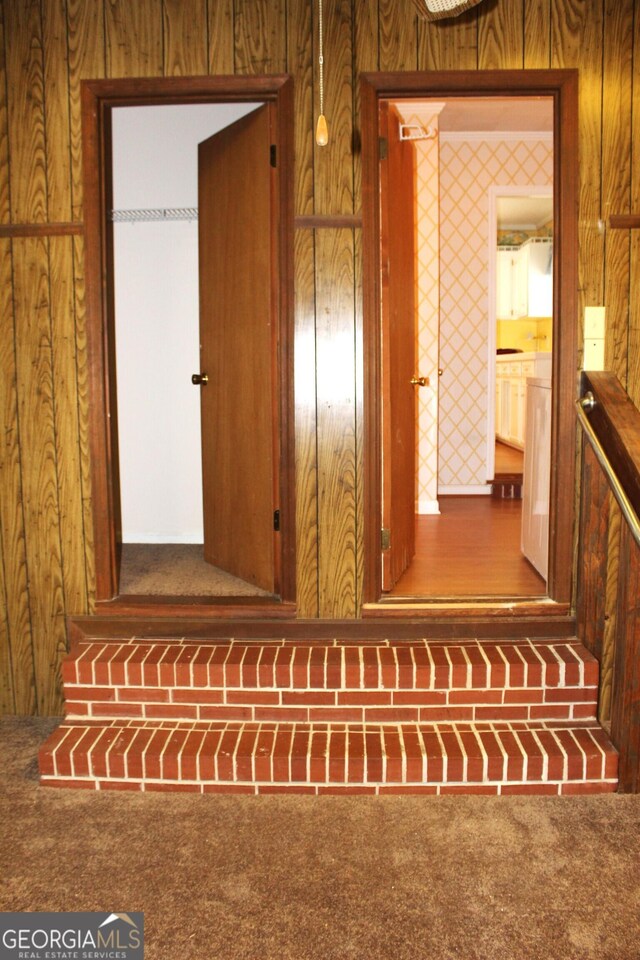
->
xmin=120 ymin=543 xmax=270 ymax=597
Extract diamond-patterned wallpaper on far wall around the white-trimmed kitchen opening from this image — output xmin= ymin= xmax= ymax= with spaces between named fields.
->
xmin=438 ymin=135 xmax=553 ymax=488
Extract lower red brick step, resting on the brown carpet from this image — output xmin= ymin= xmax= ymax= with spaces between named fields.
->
xmin=40 ymin=720 xmax=618 ymax=795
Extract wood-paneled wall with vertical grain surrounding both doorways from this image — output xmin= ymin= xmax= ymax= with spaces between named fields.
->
xmin=0 ymin=0 xmax=640 ymax=714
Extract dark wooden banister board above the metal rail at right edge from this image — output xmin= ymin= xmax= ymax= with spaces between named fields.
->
xmin=581 ymin=372 xmax=640 ymax=516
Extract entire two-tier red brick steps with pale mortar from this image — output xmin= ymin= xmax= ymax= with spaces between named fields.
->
xmin=40 ymin=640 xmax=617 ymax=794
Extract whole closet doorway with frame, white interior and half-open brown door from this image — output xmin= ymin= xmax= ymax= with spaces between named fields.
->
xmin=83 ymin=77 xmax=295 ymax=613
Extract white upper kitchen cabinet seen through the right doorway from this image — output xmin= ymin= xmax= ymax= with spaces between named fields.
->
xmin=496 ymin=237 xmax=553 ymax=320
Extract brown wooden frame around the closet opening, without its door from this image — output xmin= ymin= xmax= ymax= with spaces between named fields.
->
xmin=82 ymin=75 xmax=296 ymax=616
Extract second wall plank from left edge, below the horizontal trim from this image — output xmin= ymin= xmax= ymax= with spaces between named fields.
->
xmin=13 ymin=239 xmax=66 ymax=714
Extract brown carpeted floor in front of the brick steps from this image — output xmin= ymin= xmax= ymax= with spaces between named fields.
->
xmin=0 ymin=718 xmax=640 ymax=960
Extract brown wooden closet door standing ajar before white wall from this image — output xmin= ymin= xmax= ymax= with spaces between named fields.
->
xmin=198 ymin=105 xmax=279 ymax=593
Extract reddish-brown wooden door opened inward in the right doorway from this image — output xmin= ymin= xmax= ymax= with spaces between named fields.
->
xmin=380 ymin=104 xmax=417 ymax=590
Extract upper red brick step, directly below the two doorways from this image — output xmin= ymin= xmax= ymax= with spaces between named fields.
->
xmin=62 ymin=639 xmax=598 ymax=723
